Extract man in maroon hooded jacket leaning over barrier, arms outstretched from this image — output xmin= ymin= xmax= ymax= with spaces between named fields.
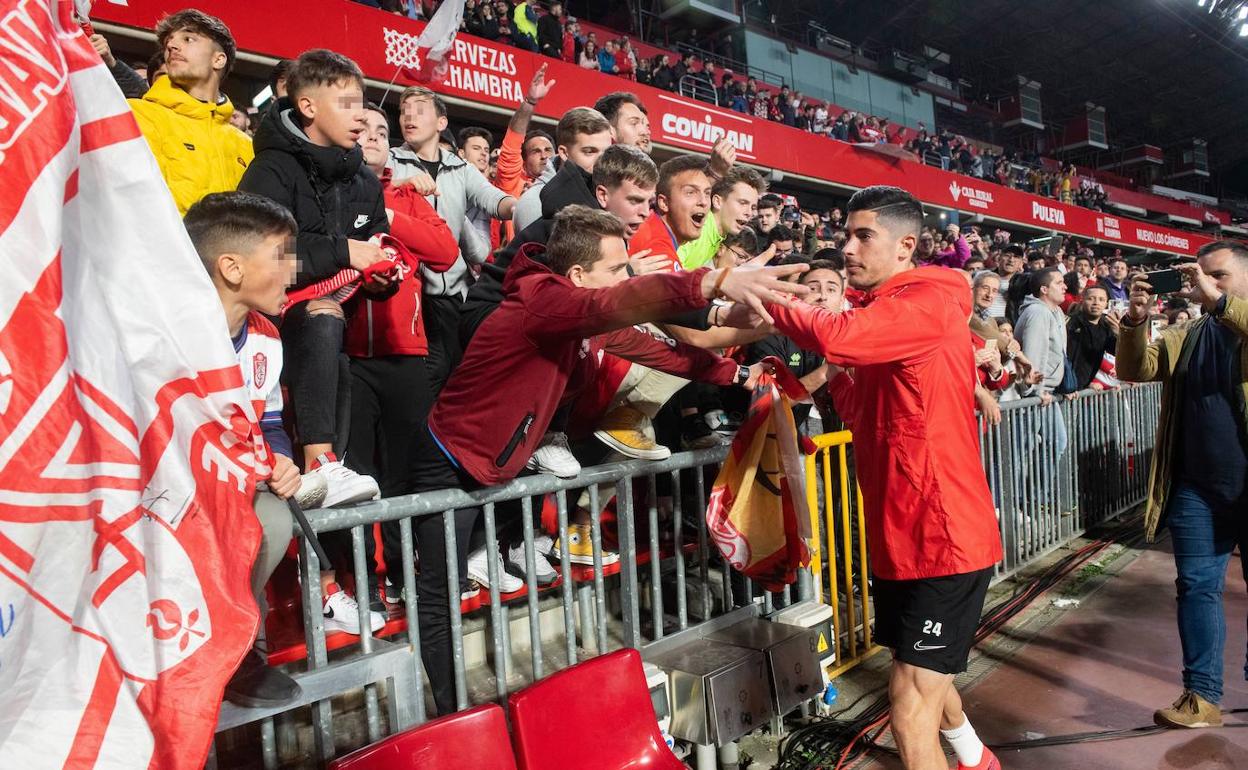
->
xmin=413 ymin=200 xmax=806 ymax=714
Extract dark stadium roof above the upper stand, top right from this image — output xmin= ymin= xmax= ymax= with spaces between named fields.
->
xmin=769 ymin=0 xmax=1248 ymax=171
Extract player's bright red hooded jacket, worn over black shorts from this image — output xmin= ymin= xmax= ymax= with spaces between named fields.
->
xmin=768 ymin=267 xmax=1002 ymax=580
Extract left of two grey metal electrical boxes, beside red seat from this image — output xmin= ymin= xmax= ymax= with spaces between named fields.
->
xmin=648 ymin=639 xmax=775 ymax=746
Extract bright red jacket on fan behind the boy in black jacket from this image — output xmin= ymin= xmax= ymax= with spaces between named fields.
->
xmin=344 ymin=168 xmax=459 ymax=358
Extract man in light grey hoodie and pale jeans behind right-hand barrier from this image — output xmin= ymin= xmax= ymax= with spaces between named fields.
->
xmin=1015 ymin=267 xmax=1067 ymax=506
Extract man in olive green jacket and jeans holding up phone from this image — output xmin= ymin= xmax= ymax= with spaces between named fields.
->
xmin=1117 ymin=241 xmax=1248 ymax=728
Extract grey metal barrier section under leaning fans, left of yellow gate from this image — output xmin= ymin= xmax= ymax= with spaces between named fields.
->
xmin=210 ymin=447 xmax=809 ymax=768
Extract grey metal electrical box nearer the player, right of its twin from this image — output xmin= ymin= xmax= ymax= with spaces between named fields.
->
xmin=706 ymin=618 xmax=824 ymax=715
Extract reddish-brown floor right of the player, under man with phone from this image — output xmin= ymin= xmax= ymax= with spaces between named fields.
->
xmin=860 ymin=542 xmax=1248 ymax=770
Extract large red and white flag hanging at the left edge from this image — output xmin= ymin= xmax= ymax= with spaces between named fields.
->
xmin=0 ymin=0 xmax=267 ymax=770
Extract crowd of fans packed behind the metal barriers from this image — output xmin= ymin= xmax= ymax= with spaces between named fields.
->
xmin=92 ymin=1 xmax=1192 ymax=713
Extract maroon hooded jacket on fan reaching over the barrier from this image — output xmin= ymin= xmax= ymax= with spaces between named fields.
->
xmin=429 ymin=249 xmax=738 ymax=485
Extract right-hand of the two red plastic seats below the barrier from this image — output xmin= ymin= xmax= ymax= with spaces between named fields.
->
xmin=506 ymin=649 xmax=685 ymax=770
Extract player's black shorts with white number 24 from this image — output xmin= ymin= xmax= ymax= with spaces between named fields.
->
xmin=872 ymin=567 xmax=992 ymax=674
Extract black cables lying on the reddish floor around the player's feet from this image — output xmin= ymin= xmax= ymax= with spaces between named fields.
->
xmin=776 ymin=517 xmax=1213 ymax=770
